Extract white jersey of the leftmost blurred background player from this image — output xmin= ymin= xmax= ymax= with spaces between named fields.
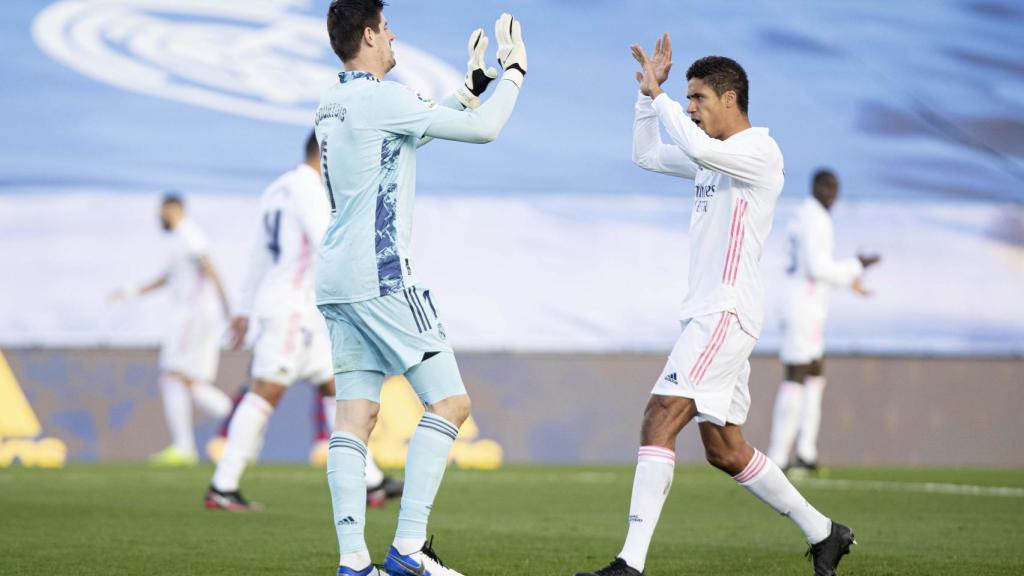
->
xmin=165 ymin=218 xmax=219 ymax=316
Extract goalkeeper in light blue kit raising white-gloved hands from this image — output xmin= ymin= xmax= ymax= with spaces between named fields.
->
xmin=315 ymin=0 xmax=526 ymax=576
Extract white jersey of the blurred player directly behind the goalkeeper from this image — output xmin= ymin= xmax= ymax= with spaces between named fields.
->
xmin=239 ymin=163 xmax=330 ymax=319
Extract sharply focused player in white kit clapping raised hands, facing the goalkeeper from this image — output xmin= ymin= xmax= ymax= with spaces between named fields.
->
xmin=584 ymin=34 xmax=853 ymax=576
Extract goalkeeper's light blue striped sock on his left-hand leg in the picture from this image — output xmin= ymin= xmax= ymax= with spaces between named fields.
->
xmin=327 ymin=431 xmax=367 ymax=557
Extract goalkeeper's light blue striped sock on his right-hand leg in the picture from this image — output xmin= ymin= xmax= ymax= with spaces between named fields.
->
xmin=394 ymin=412 xmax=459 ymax=541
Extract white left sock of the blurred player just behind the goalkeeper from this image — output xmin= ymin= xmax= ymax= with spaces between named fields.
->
xmin=212 ymin=393 xmax=273 ymax=492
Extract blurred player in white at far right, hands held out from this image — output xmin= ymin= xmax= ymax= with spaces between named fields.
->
xmin=768 ymin=170 xmax=879 ymax=470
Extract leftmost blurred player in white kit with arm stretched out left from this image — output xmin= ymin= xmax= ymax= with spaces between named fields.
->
xmin=111 ymin=193 xmax=231 ymax=465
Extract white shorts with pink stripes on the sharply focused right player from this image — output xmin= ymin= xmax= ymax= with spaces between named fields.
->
xmin=651 ymin=312 xmax=757 ymax=426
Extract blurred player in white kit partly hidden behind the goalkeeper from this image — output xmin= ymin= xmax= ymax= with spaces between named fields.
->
xmin=206 ymin=134 xmax=401 ymax=511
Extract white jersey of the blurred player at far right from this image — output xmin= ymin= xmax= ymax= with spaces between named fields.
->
xmin=783 ymin=198 xmax=864 ymax=324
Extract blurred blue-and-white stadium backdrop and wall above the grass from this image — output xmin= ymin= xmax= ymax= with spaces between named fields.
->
xmin=0 ymin=0 xmax=1024 ymax=467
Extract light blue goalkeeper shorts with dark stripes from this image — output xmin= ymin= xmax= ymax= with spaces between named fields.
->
xmin=318 ymin=286 xmax=465 ymax=400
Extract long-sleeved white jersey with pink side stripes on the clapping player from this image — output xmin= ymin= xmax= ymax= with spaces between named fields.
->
xmin=633 ymin=93 xmax=784 ymax=337
